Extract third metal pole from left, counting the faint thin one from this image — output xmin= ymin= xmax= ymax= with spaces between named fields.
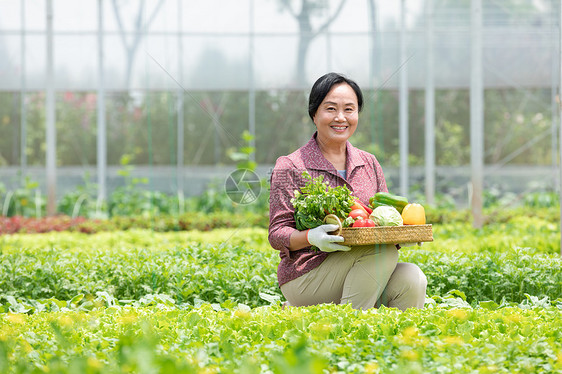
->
xmin=97 ymin=0 xmax=107 ymax=206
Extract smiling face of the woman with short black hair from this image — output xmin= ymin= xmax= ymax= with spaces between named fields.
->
xmin=312 ymin=83 xmax=359 ymax=143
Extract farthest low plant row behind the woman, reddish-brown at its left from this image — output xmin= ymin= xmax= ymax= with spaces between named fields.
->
xmin=0 ymin=204 xmax=560 ymax=235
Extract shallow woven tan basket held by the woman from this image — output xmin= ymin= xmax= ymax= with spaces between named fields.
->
xmin=332 ymin=225 xmax=433 ymax=245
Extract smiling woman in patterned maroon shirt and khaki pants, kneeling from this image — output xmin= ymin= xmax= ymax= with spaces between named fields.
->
xmin=269 ymin=73 xmax=427 ymax=310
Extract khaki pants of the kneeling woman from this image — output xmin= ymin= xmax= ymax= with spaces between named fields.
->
xmin=281 ymin=245 xmax=427 ymax=310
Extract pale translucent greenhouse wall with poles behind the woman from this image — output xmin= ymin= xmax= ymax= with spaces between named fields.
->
xmin=0 ymin=0 xmax=562 ymax=231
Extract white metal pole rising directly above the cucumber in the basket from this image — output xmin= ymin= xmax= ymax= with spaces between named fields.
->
xmin=399 ymin=0 xmax=409 ymax=196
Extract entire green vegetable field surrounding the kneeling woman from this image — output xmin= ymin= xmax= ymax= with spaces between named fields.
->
xmin=0 ymin=213 xmax=562 ymax=373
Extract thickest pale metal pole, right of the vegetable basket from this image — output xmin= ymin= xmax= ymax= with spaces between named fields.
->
xmin=470 ymin=0 xmax=484 ymax=228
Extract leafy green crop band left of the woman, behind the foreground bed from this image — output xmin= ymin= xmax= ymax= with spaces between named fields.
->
xmin=0 ymin=230 xmax=277 ymax=306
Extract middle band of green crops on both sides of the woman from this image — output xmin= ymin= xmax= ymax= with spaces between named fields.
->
xmin=0 ymin=223 xmax=562 ymax=307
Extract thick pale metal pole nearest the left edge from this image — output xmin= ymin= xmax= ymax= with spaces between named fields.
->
xmin=45 ymin=0 xmax=57 ymax=216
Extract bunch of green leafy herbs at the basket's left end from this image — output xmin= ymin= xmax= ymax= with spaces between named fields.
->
xmin=291 ymin=171 xmax=353 ymax=230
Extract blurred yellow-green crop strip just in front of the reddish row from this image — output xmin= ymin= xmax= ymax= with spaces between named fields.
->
xmin=5 ymin=216 xmax=560 ymax=254
